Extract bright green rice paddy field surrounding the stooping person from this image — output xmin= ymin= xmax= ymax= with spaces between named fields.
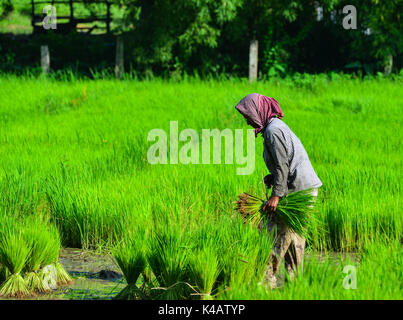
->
xmin=0 ymin=75 xmax=403 ymax=299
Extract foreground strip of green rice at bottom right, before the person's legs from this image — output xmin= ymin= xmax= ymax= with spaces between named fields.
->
xmin=221 ymin=240 xmax=403 ymax=300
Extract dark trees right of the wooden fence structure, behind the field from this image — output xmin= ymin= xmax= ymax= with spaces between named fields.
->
xmin=0 ymin=0 xmax=403 ymax=77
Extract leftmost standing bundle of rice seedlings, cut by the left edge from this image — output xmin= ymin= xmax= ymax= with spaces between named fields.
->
xmin=0 ymin=228 xmax=30 ymax=298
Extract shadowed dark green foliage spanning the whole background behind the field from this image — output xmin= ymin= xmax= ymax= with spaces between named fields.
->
xmin=0 ymin=0 xmax=403 ymax=78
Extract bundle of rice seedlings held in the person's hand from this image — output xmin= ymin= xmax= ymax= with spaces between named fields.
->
xmin=235 ymin=189 xmax=316 ymax=238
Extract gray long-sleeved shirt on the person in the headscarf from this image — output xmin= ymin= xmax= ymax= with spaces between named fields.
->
xmin=263 ymin=118 xmax=322 ymax=197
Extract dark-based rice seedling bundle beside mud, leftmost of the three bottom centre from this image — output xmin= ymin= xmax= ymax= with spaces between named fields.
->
xmin=113 ymin=233 xmax=146 ymax=300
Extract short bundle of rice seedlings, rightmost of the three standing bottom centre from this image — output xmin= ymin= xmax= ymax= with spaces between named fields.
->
xmin=188 ymin=246 xmax=221 ymax=300
